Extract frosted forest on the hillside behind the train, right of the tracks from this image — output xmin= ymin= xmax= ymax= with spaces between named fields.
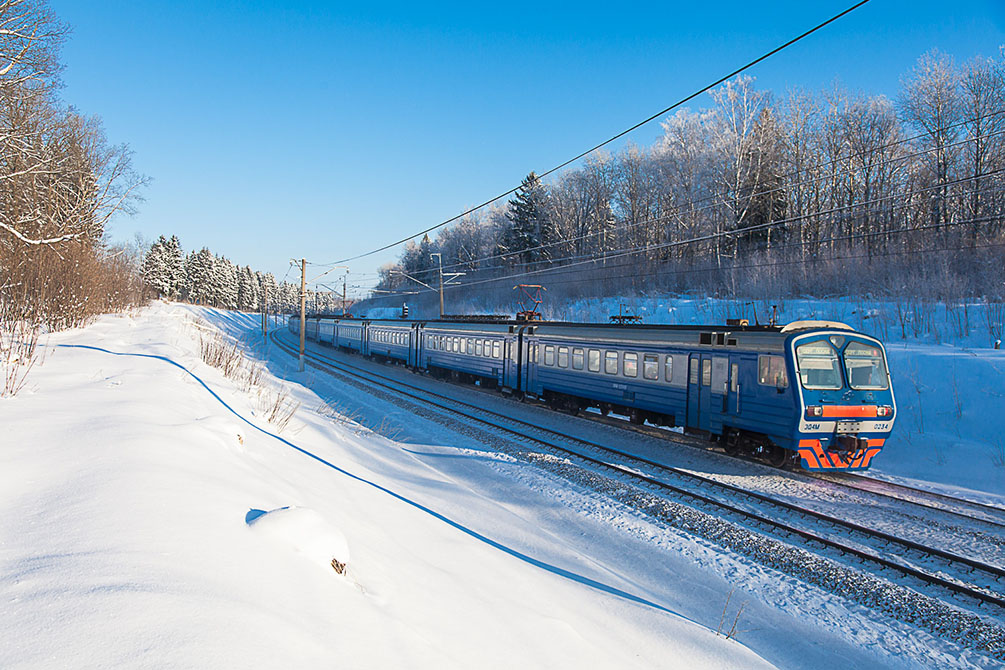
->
xmin=376 ymin=51 xmax=1005 ymax=302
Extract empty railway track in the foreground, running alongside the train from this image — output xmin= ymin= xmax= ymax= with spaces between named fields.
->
xmin=273 ymin=333 xmax=1005 ymax=617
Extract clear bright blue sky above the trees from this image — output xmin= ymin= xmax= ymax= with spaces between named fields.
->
xmin=50 ymin=0 xmax=1005 ymax=293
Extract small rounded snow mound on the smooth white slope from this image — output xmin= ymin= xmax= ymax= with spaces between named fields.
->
xmin=246 ymin=506 xmax=349 ymax=568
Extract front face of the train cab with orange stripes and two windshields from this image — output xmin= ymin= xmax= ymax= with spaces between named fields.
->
xmin=790 ymin=331 xmax=896 ymax=470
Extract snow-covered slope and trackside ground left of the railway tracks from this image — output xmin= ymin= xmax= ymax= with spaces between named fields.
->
xmin=0 ymin=303 xmax=993 ymax=670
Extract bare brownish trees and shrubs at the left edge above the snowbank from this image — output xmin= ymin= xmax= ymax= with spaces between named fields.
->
xmin=0 ymin=0 xmax=144 ymax=333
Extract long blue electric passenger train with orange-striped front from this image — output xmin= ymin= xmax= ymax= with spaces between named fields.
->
xmin=288 ymin=317 xmax=896 ymax=470
